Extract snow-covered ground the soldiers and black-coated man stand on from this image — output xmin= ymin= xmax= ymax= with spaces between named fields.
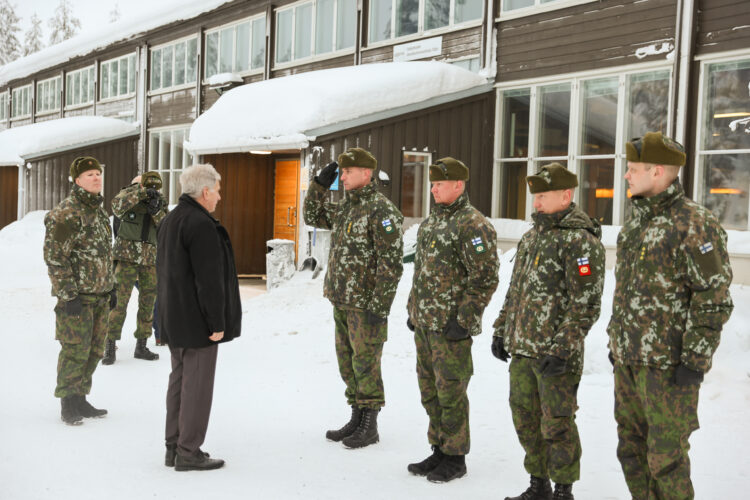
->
xmin=0 ymin=212 xmax=750 ymax=500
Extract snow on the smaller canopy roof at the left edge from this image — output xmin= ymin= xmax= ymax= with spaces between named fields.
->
xmin=0 ymin=116 xmax=140 ymax=166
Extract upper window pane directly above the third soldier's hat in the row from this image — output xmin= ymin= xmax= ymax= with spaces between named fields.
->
xmin=537 ymin=83 xmax=570 ymax=156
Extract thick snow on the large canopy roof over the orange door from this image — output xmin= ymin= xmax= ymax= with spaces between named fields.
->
xmin=185 ymin=61 xmax=487 ymax=154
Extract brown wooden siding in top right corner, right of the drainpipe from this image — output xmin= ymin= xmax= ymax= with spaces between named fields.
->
xmin=695 ymin=0 xmax=750 ymax=55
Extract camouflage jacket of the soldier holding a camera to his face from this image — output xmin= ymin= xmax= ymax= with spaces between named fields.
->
xmin=112 ymin=183 xmax=167 ymax=266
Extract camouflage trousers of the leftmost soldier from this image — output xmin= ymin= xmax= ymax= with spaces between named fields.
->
xmin=55 ymin=294 xmax=109 ymax=398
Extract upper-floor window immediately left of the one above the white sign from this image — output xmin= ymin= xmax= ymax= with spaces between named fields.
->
xmin=275 ymin=0 xmax=357 ymax=63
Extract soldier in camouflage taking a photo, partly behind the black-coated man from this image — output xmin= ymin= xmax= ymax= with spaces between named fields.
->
xmin=102 ymin=172 xmax=167 ymax=365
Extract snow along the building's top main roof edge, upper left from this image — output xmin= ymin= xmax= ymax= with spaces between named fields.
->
xmin=0 ymin=0 xmax=232 ymax=85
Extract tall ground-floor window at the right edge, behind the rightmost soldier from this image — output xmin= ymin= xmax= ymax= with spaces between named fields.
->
xmin=696 ymin=59 xmax=750 ymax=229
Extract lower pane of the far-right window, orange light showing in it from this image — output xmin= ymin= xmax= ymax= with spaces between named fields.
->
xmin=701 ymin=154 xmax=750 ymax=229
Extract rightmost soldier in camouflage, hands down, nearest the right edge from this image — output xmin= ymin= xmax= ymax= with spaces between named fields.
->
xmin=607 ymin=132 xmax=733 ymax=500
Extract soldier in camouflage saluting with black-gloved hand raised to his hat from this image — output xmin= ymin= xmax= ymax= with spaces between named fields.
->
xmin=305 ymin=148 xmax=403 ymax=448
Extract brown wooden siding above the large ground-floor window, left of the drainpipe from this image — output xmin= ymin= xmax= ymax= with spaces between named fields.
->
xmin=497 ymin=0 xmax=677 ymax=82
